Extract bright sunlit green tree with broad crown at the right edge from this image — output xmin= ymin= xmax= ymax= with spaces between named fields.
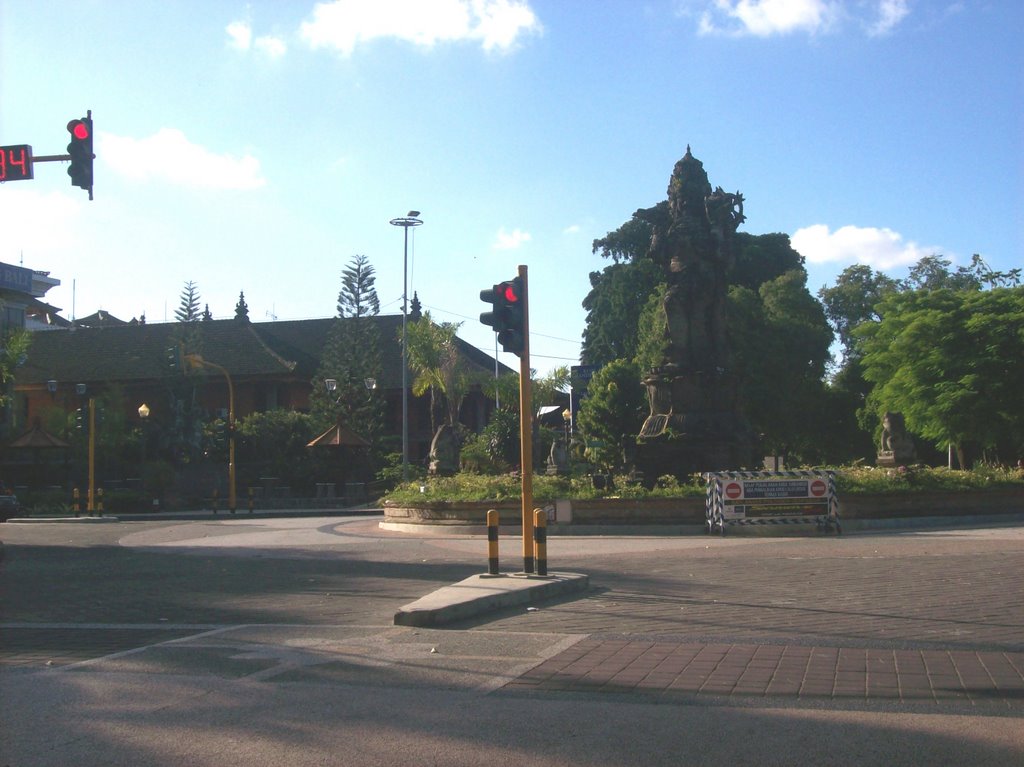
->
xmin=854 ymin=287 xmax=1024 ymax=465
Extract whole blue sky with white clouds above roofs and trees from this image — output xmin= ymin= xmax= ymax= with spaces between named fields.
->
xmin=0 ymin=0 xmax=1024 ymax=372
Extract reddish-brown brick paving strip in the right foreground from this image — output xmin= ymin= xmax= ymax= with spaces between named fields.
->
xmin=506 ymin=638 xmax=1024 ymax=712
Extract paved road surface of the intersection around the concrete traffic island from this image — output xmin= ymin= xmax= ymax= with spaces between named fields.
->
xmin=0 ymin=518 xmax=1024 ymax=767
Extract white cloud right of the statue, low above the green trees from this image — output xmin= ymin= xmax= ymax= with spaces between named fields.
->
xmin=791 ymin=224 xmax=942 ymax=269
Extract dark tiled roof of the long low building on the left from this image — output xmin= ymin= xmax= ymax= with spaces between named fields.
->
xmin=15 ymin=314 xmax=510 ymax=388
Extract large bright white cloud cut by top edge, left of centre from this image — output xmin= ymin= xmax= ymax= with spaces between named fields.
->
xmin=299 ymin=0 xmax=542 ymax=56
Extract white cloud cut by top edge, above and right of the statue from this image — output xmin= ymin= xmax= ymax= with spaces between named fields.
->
xmin=696 ymin=0 xmax=910 ymax=37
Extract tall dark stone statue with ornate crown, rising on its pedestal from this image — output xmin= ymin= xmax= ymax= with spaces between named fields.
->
xmin=637 ymin=146 xmax=753 ymax=480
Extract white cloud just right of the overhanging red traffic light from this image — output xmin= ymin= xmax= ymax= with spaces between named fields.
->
xmin=96 ymin=128 xmax=266 ymax=189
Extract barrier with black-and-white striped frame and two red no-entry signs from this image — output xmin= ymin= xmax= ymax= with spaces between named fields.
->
xmin=703 ymin=470 xmax=843 ymax=535
